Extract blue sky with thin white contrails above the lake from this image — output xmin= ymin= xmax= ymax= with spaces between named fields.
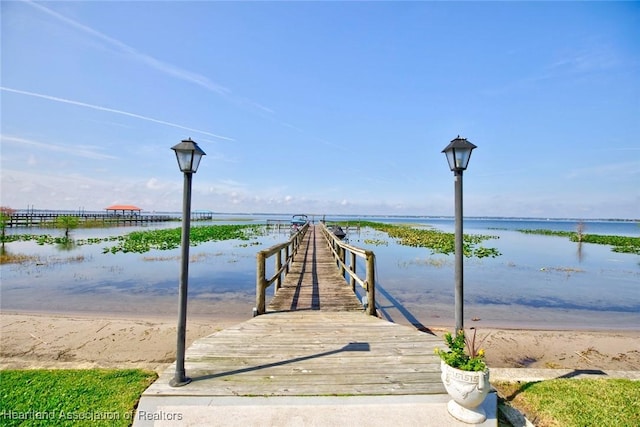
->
xmin=0 ymin=1 xmax=640 ymax=219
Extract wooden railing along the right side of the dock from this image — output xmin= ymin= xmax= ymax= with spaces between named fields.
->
xmin=320 ymin=223 xmax=377 ymax=316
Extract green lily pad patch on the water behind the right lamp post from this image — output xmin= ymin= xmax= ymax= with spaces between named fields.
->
xmin=360 ymin=221 xmax=500 ymax=258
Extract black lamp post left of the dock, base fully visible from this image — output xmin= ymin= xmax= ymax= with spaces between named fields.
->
xmin=169 ymin=138 xmax=206 ymax=387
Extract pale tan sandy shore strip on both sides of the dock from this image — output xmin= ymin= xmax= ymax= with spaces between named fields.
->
xmin=0 ymin=312 xmax=640 ymax=372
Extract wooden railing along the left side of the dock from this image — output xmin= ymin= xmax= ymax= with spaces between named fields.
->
xmin=254 ymin=222 xmax=309 ymax=316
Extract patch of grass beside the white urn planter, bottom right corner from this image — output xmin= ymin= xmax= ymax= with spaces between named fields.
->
xmin=493 ymin=379 xmax=640 ymax=427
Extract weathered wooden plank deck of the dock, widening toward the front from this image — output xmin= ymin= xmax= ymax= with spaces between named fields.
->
xmin=143 ymin=227 xmax=445 ymax=399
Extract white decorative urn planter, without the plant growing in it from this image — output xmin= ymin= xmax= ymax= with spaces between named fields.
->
xmin=440 ymin=361 xmax=491 ymax=424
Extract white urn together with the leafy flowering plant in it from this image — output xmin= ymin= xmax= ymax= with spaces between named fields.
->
xmin=435 ymin=328 xmax=491 ymax=424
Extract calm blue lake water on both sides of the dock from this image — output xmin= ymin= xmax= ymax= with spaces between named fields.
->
xmin=0 ymin=215 xmax=640 ymax=330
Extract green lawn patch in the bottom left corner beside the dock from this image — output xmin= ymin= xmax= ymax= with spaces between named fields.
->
xmin=0 ymin=369 xmax=157 ymax=426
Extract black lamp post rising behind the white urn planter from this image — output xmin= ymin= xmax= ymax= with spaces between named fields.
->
xmin=442 ymin=135 xmax=476 ymax=334
